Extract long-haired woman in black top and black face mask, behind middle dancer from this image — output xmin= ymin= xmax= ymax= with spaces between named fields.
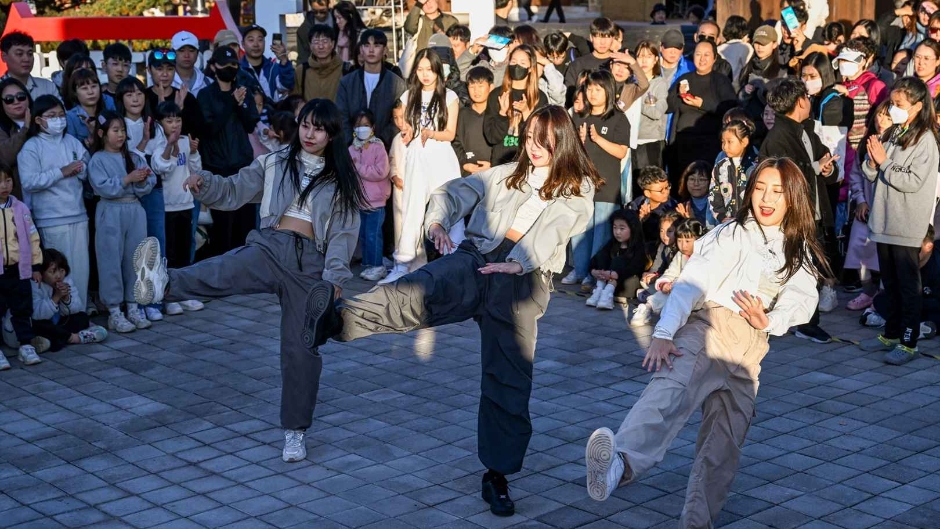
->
xmin=483 ymin=44 xmax=548 ymax=166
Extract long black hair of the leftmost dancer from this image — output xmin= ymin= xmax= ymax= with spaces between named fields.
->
xmin=279 ymin=99 xmax=368 ymax=219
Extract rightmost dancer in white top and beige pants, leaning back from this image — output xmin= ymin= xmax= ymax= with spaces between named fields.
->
xmin=585 ymin=158 xmax=829 ymax=527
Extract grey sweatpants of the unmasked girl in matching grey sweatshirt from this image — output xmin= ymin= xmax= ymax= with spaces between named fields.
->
xmin=95 ymin=199 xmax=147 ymax=309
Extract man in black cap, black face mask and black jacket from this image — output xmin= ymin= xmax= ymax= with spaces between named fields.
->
xmin=196 ymin=46 xmax=261 ymax=256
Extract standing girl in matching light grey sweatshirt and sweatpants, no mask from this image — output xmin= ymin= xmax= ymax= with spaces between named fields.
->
xmin=88 ymin=112 xmax=157 ymax=333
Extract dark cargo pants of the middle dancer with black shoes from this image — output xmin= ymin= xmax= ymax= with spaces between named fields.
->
xmin=337 ymin=240 xmax=549 ymax=474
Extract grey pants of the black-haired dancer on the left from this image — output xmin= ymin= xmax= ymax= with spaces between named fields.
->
xmin=164 ymin=229 xmax=323 ymax=430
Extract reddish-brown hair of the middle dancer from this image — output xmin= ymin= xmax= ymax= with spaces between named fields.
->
xmin=506 ymin=105 xmax=603 ymax=201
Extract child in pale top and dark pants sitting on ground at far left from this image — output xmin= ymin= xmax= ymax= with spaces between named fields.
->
xmin=32 ymin=249 xmax=108 ymax=351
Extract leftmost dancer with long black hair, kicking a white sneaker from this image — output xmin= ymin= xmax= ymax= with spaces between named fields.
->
xmin=134 ymin=99 xmax=366 ymax=463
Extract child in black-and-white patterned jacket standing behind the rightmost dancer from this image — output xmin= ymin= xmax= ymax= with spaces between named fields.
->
xmin=708 ymin=120 xmax=757 ymax=223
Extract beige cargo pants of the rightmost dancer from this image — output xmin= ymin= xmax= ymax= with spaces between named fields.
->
xmin=615 ymin=303 xmax=768 ymax=528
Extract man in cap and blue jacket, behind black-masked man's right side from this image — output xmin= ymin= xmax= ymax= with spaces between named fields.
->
xmin=241 ymin=24 xmax=294 ymax=103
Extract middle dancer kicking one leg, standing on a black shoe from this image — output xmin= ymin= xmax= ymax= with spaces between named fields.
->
xmin=337 ymin=106 xmax=600 ymax=516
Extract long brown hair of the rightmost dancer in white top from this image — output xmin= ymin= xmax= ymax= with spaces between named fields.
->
xmin=719 ymin=158 xmax=832 ymax=282
